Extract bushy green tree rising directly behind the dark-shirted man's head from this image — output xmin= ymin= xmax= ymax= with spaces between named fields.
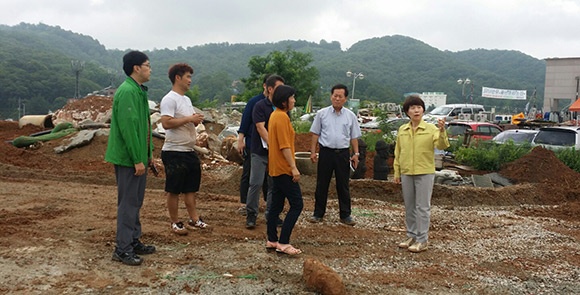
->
xmin=241 ymin=48 xmax=319 ymax=106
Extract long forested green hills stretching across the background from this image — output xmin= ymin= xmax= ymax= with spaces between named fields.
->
xmin=0 ymin=23 xmax=545 ymax=119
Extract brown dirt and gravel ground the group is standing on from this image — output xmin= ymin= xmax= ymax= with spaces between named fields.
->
xmin=0 ymin=99 xmax=580 ymax=294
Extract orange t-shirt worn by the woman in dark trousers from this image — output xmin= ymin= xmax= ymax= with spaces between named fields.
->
xmin=268 ymin=109 xmax=295 ymax=176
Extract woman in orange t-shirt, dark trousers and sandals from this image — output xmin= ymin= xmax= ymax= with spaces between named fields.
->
xmin=266 ymin=85 xmax=304 ymax=255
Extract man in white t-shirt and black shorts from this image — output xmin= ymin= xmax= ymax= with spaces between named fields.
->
xmin=160 ymin=63 xmax=208 ymax=235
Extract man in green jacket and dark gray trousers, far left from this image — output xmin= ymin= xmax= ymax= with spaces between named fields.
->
xmin=105 ymin=51 xmax=155 ymax=265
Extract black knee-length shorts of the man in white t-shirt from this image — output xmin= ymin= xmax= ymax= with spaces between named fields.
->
xmin=161 ymin=151 xmax=201 ymax=194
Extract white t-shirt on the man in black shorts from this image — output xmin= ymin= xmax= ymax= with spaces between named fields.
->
xmin=159 ymin=90 xmax=197 ymax=152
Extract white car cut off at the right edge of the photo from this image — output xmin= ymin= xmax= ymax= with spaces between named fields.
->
xmin=533 ymin=126 xmax=580 ymax=150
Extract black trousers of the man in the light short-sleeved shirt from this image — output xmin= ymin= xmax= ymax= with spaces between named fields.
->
xmin=314 ymin=146 xmax=351 ymax=219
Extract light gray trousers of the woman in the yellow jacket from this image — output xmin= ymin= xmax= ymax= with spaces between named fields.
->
xmin=401 ymin=174 xmax=435 ymax=243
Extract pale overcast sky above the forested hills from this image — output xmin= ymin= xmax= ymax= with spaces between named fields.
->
xmin=0 ymin=0 xmax=580 ymax=59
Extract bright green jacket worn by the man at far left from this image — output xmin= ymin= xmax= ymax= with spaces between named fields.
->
xmin=105 ymin=77 xmax=153 ymax=167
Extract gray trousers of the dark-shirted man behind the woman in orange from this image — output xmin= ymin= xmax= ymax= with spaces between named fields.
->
xmin=246 ymin=153 xmax=273 ymax=216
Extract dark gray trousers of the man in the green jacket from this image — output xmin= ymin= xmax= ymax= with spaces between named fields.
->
xmin=115 ymin=165 xmax=147 ymax=253
